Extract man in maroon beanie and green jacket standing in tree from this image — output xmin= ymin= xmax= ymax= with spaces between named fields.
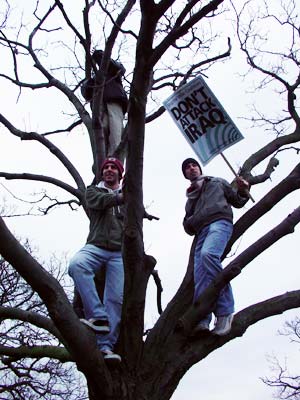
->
xmin=69 ymin=157 xmax=124 ymax=362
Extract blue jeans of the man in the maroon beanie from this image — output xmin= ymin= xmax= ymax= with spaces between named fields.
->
xmin=69 ymin=244 xmax=124 ymax=350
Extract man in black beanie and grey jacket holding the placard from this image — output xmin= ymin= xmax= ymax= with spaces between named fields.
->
xmin=182 ymin=158 xmax=249 ymax=336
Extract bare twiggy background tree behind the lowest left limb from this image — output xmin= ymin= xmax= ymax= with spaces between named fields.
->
xmin=0 ymin=248 xmax=87 ymax=400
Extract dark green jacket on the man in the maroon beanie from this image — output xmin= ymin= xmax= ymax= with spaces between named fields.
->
xmin=85 ymin=185 xmax=123 ymax=251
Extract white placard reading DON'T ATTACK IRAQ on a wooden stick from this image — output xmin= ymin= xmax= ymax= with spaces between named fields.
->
xmin=163 ymin=76 xmax=243 ymax=165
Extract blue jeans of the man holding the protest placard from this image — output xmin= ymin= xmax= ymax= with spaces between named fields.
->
xmin=194 ymin=219 xmax=234 ymax=323
